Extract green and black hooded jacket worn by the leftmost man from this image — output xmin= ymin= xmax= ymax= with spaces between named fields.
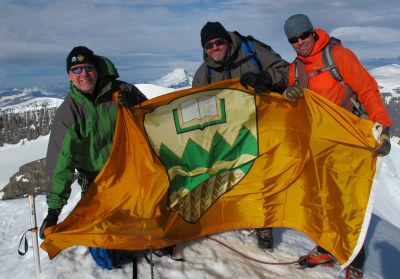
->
xmin=46 ymin=56 xmax=146 ymax=208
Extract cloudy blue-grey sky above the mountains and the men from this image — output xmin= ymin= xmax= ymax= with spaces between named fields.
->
xmin=0 ymin=0 xmax=400 ymax=88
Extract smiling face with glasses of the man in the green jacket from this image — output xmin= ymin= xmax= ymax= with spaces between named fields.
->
xmin=68 ymin=64 xmax=98 ymax=94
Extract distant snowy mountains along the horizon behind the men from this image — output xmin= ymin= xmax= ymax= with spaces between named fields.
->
xmin=0 ymin=64 xmax=400 ymax=147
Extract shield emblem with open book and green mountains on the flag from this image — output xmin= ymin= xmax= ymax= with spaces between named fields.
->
xmin=144 ymin=89 xmax=258 ymax=223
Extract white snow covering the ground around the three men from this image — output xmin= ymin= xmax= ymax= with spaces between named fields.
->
xmin=0 ymin=82 xmax=400 ymax=279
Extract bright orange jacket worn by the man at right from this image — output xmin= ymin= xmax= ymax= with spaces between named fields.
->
xmin=289 ymin=29 xmax=392 ymax=127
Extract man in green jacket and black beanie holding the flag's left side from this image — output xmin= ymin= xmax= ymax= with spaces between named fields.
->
xmin=40 ymin=46 xmax=147 ymax=239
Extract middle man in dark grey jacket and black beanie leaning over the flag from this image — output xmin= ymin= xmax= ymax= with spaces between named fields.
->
xmin=192 ymin=22 xmax=289 ymax=251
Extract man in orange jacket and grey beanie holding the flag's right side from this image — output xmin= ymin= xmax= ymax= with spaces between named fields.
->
xmin=283 ymin=14 xmax=392 ymax=279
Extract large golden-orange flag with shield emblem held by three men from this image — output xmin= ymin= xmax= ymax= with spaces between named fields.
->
xmin=42 ymin=80 xmax=378 ymax=265
